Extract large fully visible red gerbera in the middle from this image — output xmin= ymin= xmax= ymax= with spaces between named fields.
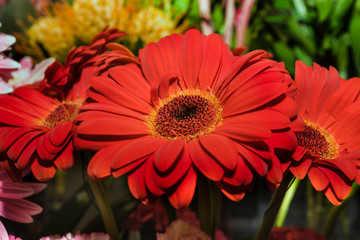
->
xmin=74 ymin=30 xmax=296 ymax=208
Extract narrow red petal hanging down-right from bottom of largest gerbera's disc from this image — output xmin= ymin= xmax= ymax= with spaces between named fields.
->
xmin=188 ymin=139 xmax=224 ymax=181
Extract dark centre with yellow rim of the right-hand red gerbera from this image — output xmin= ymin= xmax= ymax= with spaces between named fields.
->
xmin=296 ymin=120 xmax=339 ymax=159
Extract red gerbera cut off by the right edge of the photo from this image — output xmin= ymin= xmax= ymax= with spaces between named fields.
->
xmin=290 ymin=61 xmax=360 ymax=205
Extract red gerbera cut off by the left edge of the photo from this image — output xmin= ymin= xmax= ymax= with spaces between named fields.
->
xmin=0 ymin=81 xmax=85 ymax=181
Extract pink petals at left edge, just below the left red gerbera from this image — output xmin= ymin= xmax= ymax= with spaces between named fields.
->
xmin=0 ymin=170 xmax=46 ymax=223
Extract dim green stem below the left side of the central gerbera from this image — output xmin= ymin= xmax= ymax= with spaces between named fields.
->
xmin=89 ymin=178 xmax=120 ymax=240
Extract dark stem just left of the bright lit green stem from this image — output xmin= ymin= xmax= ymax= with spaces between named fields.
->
xmin=256 ymin=172 xmax=293 ymax=240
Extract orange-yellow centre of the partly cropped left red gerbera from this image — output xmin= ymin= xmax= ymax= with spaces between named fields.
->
xmin=40 ymin=102 xmax=81 ymax=128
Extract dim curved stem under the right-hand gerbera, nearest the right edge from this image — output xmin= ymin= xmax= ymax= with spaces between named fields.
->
xmin=322 ymin=182 xmax=359 ymax=239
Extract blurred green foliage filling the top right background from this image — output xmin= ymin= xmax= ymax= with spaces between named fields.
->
xmin=247 ymin=0 xmax=360 ymax=78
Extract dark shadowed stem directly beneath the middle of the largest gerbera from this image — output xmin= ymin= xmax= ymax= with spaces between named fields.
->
xmin=198 ymin=175 xmax=220 ymax=239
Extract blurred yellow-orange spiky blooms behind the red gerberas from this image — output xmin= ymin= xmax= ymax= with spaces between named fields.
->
xmin=15 ymin=0 xmax=187 ymax=62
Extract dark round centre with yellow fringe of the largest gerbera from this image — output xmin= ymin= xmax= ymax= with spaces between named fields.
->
xmin=148 ymin=90 xmax=222 ymax=142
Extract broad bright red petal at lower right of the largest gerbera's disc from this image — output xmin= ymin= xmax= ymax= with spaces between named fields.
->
xmin=199 ymin=134 xmax=238 ymax=170
